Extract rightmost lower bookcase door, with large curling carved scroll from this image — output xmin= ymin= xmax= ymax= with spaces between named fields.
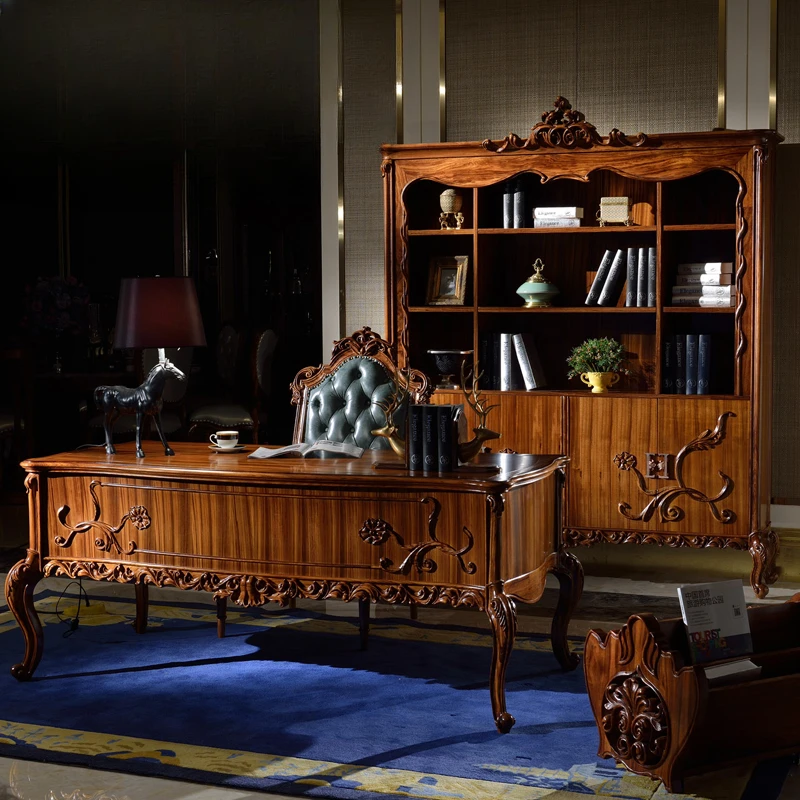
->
xmin=654 ymin=398 xmax=751 ymax=537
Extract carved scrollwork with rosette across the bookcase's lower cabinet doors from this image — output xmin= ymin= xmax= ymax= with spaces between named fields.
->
xmin=613 ymin=411 xmax=736 ymax=525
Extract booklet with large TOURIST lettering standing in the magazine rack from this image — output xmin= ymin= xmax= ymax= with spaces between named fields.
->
xmin=678 ymin=579 xmax=753 ymax=664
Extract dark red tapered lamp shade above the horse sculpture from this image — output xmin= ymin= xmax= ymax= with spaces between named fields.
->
xmin=114 ymin=277 xmax=206 ymax=348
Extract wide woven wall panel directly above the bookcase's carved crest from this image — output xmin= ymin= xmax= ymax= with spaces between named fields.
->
xmin=446 ymin=0 xmax=718 ymax=141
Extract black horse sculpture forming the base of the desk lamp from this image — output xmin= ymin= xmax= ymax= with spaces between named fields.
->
xmin=94 ymin=358 xmax=186 ymax=458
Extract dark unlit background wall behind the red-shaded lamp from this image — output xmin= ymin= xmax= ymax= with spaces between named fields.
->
xmin=0 ymin=0 xmax=321 ymax=450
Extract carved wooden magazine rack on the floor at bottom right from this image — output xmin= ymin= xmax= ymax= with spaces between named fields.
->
xmin=583 ymin=593 xmax=800 ymax=792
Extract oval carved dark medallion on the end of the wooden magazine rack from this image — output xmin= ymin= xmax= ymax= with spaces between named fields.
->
xmin=601 ymin=672 xmax=669 ymax=768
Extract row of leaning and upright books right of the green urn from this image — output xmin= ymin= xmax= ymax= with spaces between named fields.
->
xmin=586 ymin=247 xmax=656 ymax=308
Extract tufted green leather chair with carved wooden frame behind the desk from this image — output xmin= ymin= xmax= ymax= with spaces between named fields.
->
xmin=212 ymin=327 xmax=433 ymax=636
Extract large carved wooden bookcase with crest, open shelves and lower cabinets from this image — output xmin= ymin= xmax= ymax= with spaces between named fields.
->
xmin=381 ymin=98 xmax=781 ymax=597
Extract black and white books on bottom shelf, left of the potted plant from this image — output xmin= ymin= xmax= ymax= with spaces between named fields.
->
xmin=478 ymin=333 xmax=547 ymax=391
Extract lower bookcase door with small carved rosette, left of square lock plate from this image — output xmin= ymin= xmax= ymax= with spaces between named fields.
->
xmin=567 ymin=396 xmax=659 ymax=532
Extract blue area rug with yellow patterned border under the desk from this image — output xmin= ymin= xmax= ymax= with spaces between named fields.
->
xmin=0 ymin=584 xmax=788 ymax=800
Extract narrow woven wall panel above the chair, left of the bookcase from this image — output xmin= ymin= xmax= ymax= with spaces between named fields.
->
xmin=342 ymin=0 xmax=397 ymax=334
